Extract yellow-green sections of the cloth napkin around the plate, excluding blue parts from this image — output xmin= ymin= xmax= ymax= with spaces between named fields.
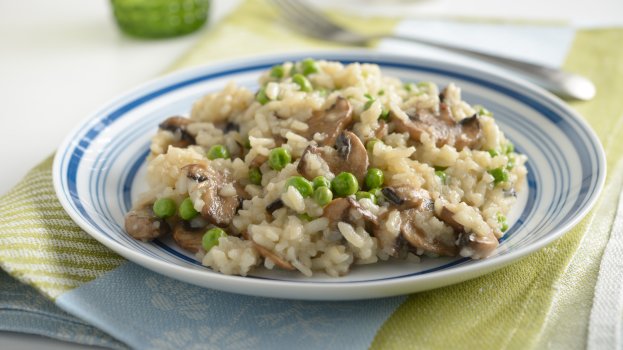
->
xmin=0 ymin=1 xmax=623 ymax=349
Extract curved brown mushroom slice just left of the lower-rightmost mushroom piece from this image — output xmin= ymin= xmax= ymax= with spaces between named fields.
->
xmin=400 ymin=209 xmax=458 ymax=256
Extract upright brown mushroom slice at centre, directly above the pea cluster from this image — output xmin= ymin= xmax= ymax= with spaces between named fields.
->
xmin=297 ymin=131 xmax=370 ymax=183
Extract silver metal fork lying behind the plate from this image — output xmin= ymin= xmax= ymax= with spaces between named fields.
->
xmin=271 ymin=0 xmax=595 ymax=101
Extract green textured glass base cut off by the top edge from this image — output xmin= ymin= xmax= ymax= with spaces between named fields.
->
xmin=111 ymin=0 xmax=210 ymax=38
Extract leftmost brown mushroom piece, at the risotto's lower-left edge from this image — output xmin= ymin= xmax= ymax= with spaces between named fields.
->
xmin=124 ymin=204 xmax=171 ymax=241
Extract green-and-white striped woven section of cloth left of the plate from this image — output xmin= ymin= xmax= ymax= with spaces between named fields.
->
xmin=0 ymin=157 xmax=125 ymax=299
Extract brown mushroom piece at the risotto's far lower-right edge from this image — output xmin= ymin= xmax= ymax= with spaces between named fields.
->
xmin=438 ymin=206 xmax=499 ymax=259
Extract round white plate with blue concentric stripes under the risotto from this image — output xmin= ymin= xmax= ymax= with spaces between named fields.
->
xmin=53 ymin=51 xmax=606 ymax=300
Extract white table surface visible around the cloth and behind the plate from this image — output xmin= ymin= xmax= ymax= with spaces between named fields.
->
xmin=0 ymin=0 xmax=623 ymax=349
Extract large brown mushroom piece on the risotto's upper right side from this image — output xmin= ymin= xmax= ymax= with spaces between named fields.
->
xmin=391 ymin=103 xmax=482 ymax=151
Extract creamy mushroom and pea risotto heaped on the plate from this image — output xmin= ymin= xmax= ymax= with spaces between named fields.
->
xmin=125 ymin=59 xmax=526 ymax=276
